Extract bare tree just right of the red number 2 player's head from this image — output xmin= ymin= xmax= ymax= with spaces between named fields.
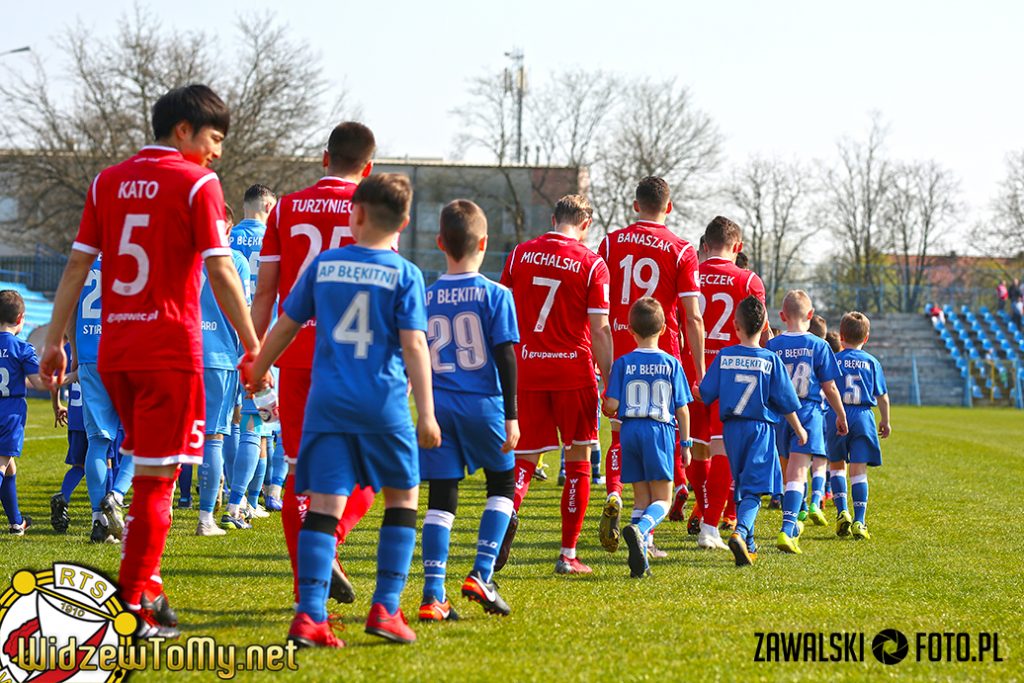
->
xmin=726 ymin=157 xmax=819 ymax=305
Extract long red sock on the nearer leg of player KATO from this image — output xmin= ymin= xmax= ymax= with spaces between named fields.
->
xmin=118 ymin=475 xmax=174 ymax=609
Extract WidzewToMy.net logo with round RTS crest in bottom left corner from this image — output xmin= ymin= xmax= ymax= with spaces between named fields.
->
xmin=0 ymin=563 xmax=298 ymax=683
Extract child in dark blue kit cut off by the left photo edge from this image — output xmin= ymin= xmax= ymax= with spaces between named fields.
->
xmin=0 ymin=290 xmax=47 ymax=536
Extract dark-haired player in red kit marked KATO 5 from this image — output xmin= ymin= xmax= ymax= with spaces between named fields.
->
xmin=40 ymin=85 xmax=259 ymax=638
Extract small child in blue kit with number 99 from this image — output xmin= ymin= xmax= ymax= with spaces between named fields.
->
xmin=601 ymin=297 xmax=693 ymax=579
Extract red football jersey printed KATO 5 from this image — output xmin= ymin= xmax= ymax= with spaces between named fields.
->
xmin=72 ymin=145 xmax=231 ymax=372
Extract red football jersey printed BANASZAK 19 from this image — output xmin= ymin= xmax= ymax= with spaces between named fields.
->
xmin=597 ymin=220 xmax=700 ymax=358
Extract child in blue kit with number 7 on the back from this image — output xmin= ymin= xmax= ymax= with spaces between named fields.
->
xmin=700 ymin=297 xmax=807 ymax=566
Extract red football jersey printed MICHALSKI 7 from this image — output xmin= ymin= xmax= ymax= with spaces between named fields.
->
xmin=502 ymin=232 xmax=608 ymax=390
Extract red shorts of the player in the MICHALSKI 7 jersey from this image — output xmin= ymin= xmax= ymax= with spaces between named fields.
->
xmin=515 ymin=387 xmax=598 ymax=454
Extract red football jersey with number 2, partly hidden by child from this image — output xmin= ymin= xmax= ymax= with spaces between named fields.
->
xmin=700 ymin=256 xmax=765 ymax=368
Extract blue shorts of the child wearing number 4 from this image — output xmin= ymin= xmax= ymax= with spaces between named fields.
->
xmin=295 ymin=423 xmax=420 ymax=496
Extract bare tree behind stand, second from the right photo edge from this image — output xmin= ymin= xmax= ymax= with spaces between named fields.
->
xmin=882 ymin=162 xmax=961 ymax=312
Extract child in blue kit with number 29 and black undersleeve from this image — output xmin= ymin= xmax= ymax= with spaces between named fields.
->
xmin=420 ymin=200 xmax=519 ymax=622
